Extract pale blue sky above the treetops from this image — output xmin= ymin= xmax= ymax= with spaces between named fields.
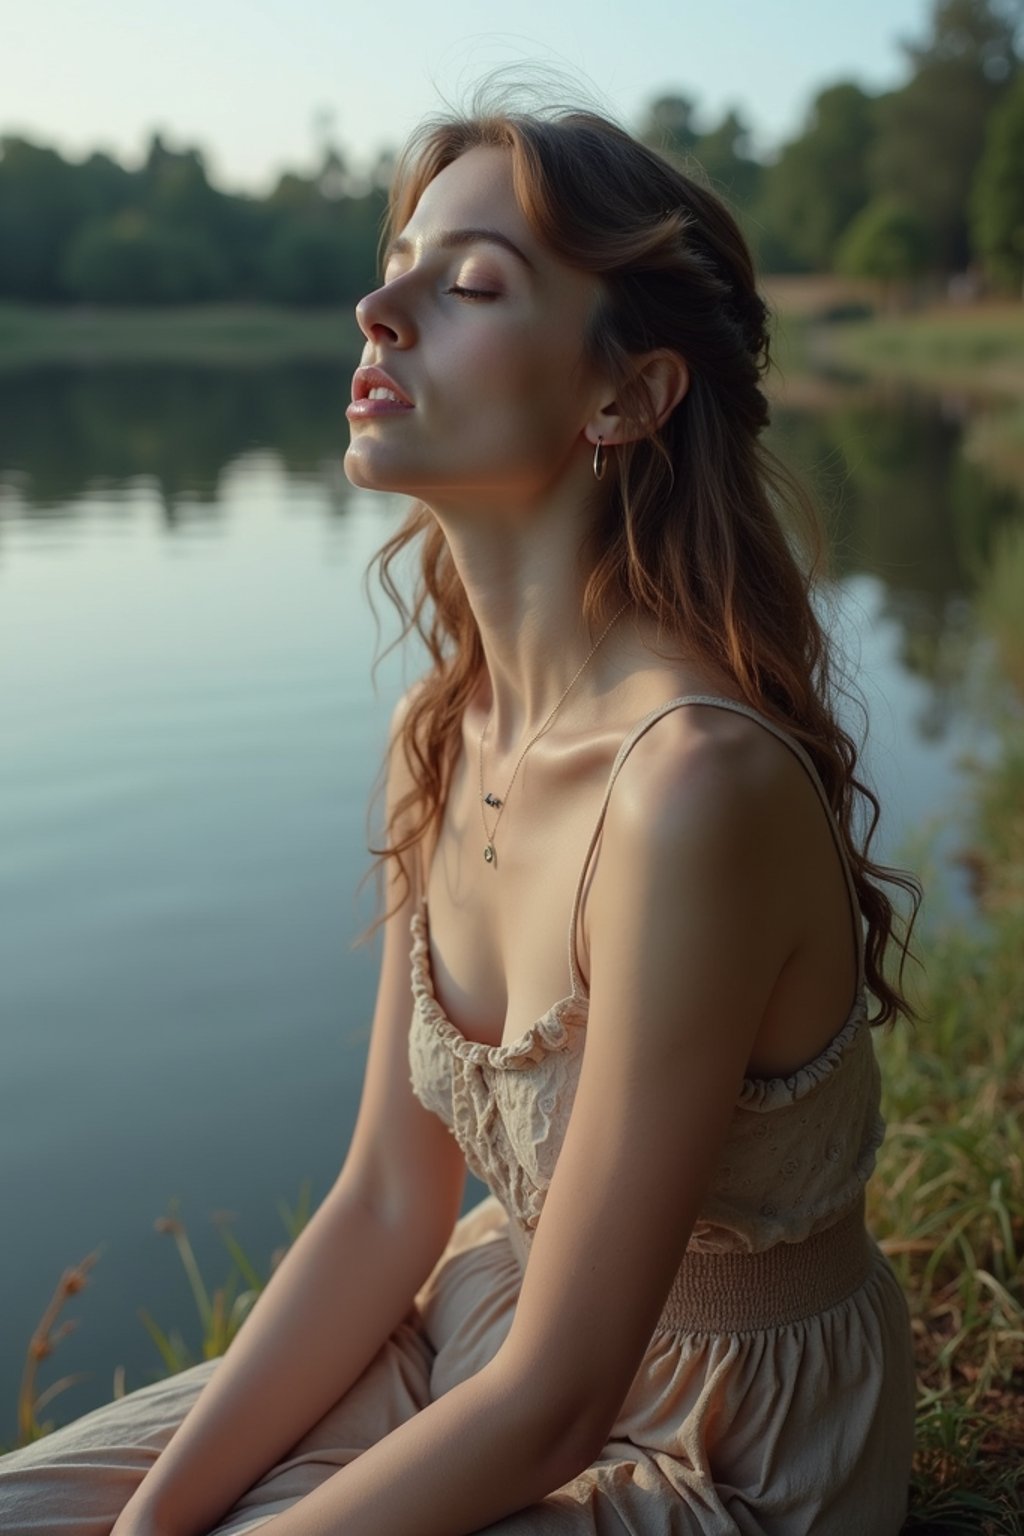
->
xmin=0 ymin=0 xmax=932 ymax=192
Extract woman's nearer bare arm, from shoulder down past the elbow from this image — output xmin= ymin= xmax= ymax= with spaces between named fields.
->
xmin=256 ymin=709 xmax=794 ymax=1536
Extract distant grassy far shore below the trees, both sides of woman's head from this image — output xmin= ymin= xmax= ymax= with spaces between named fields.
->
xmin=0 ymin=291 xmax=1024 ymax=487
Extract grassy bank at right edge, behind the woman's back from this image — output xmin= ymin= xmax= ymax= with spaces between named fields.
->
xmin=869 ymin=524 xmax=1024 ymax=1536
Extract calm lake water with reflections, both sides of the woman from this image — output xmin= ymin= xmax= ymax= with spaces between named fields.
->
xmin=0 ymin=367 xmax=1015 ymax=1442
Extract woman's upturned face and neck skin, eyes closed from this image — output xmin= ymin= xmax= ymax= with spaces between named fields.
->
xmin=344 ymin=147 xmax=688 ymax=761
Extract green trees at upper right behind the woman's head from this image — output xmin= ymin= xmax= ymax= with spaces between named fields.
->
xmin=645 ymin=0 xmax=1024 ymax=293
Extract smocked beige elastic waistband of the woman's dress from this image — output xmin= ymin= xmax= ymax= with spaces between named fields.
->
xmin=508 ymin=1195 xmax=877 ymax=1333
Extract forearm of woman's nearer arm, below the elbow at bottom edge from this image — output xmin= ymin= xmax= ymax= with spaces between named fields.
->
xmin=254 ymin=1359 xmax=599 ymax=1536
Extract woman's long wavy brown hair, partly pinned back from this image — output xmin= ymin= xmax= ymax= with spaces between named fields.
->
xmin=359 ymin=81 xmax=921 ymax=1025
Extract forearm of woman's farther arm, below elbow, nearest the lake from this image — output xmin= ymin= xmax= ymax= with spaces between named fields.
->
xmin=122 ymin=1187 xmax=444 ymax=1536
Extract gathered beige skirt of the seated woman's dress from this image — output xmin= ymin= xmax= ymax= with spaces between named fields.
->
xmin=0 ymin=1198 xmax=913 ymax=1536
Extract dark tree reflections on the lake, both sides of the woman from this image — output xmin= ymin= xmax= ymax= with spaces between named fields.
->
xmin=0 ymin=359 xmax=1021 ymax=703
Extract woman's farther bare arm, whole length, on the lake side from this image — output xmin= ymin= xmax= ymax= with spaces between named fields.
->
xmin=112 ymin=703 xmax=465 ymax=1536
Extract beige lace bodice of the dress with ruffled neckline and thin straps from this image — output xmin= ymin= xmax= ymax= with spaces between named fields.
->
xmin=408 ymin=696 xmax=884 ymax=1253
